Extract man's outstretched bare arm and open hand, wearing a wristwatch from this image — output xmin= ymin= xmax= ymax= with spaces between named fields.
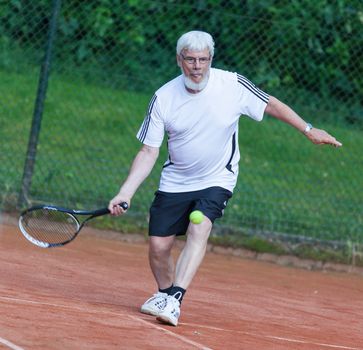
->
xmin=265 ymin=96 xmax=342 ymax=147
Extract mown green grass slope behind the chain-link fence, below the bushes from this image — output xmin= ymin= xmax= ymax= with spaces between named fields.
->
xmin=0 ymin=63 xmax=363 ymax=266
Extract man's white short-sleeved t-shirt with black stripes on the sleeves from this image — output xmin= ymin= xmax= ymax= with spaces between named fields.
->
xmin=137 ymin=68 xmax=269 ymax=192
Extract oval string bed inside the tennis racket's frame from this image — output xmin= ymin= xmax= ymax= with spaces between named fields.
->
xmin=21 ymin=208 xmax=80 ymax=244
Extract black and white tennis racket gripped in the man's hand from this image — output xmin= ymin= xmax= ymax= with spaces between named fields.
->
xmin=19 ymin=202 xmax=128 ymax=248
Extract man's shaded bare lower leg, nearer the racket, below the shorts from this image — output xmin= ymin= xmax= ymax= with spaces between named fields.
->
xmin=149 ymin=236 xmax=175 ymax=289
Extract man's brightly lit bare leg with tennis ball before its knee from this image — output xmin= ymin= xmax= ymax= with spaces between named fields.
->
xmin=175 ymin=216 xmax=212 ymax=289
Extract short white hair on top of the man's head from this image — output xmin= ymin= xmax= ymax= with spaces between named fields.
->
xmin=176 ymin=30 xmax=214 ymax=57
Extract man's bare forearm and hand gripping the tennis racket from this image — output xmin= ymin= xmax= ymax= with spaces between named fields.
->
xmin=108 ymin=145 xmax=159 ymax=215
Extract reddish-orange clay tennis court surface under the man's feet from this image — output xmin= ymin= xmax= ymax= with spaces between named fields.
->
xmin=0 ymin=221 xmax=363 ymax=350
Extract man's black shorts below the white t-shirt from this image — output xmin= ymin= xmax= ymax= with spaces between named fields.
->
xmin=149 ymin=187 xmax=232 ymax=237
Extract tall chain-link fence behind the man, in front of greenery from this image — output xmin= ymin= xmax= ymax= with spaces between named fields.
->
xmin=0 ymin=0 xmax=363 ymax=252
